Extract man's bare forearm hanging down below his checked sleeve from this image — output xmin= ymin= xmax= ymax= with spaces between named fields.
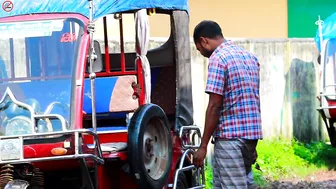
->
xmin=200 ymin=93 xmax=223 ymax=148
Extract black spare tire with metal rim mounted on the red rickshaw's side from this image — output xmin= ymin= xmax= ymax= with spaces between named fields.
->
xmin=127 ymin=104 xmax=172 ymax=189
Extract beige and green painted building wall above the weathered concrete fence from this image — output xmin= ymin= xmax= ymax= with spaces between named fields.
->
xmin=97 ymin=0 xmax=336 ymax=38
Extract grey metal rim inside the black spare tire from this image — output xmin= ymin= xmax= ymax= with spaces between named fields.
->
xmin=143 ymin=118 xmax=170 ymax=180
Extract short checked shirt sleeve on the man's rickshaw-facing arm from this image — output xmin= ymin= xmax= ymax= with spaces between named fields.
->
xmin=205 ymin=56 xmax=225 ymax=95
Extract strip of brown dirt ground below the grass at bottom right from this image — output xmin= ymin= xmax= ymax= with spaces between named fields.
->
xmin=256 ymin=171 xmax=336 ymax=189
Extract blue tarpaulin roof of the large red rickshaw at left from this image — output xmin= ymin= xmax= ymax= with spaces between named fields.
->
xmin=0 ymin=0 xmax=189 ymax=20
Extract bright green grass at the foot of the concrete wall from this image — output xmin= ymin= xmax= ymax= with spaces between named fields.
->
xmin=205 ymin=139 xmax=336 ymax=189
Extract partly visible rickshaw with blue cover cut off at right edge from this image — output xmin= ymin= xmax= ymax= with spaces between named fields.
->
xmin=315 ymin=13 xmax=336 ymax=147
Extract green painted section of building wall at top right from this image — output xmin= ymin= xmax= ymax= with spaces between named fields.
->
xmin=288 ymin=0 xmax=336 ymax=38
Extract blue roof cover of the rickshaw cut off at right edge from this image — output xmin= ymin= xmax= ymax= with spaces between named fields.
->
xmin=315 ymin=12 xmax=336 ymax=51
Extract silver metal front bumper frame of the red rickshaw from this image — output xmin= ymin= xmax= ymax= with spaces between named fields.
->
xmin=0 ymin=129 xmax=104 ymax=164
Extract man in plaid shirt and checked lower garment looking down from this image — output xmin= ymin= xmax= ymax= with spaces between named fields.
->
xmin=193 ymin=20 xmax=262 ymax=189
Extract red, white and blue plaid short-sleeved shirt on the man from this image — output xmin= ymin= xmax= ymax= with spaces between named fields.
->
xmin=205 ymin=41 xmax=262 ymax=140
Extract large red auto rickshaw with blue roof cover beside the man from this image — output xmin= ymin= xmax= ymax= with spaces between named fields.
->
xmin=0 ymin=0 xmax=205 ymax=189
